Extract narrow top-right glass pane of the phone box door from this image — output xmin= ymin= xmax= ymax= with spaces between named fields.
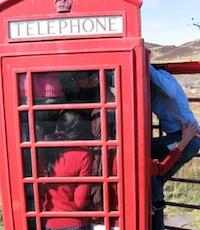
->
xmin=104 ymin=70 xmax=116 ymax=102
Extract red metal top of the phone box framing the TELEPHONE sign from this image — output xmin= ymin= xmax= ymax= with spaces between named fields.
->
xmin=0 ymin=0 xmax=142 ymax=44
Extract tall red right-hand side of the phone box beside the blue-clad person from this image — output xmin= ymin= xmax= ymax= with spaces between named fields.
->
xmin=135 ymin=47 xmax=151 ymax=229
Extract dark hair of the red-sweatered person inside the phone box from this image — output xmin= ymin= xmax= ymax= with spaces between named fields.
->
xmin=45 ymin=110 xmax=87 ymax=176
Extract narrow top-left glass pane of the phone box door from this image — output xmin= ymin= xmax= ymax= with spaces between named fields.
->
xmin=17 ymin=73 xmax=28 ymax=105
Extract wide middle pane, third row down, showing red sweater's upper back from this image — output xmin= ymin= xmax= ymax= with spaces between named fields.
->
xmin=37 ymin=147 xmax=93 ymax=177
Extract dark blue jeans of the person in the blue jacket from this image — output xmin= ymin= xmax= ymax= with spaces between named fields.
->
xmin=152 ymin=133 xmax=200 ymax=230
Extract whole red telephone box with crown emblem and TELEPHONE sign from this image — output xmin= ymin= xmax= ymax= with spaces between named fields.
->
xmin=0 ymin=0 xmax=150 ymax=230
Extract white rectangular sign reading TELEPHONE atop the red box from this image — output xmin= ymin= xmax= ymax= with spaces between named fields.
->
xmin=8 ymin=15 xmax=123 ymax=39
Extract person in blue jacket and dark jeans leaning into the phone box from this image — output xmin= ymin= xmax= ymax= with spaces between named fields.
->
xmin=150 ymin=65 xmax=200 ymax=230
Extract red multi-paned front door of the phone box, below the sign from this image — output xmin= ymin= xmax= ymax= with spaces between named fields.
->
xmin=2 ymin=51 xmax=145 ymax=230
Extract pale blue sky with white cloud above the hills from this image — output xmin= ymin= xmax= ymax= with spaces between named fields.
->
xmin=141 ymin=0 xmax=200 ymax=46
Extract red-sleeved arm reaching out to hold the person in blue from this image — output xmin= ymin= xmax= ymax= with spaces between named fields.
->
xmin=151 ymin=124 xmax=197 ymax=176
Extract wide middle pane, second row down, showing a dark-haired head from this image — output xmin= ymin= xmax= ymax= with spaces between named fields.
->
xmin=35 ymin=109 xmax=93 ymax=141
